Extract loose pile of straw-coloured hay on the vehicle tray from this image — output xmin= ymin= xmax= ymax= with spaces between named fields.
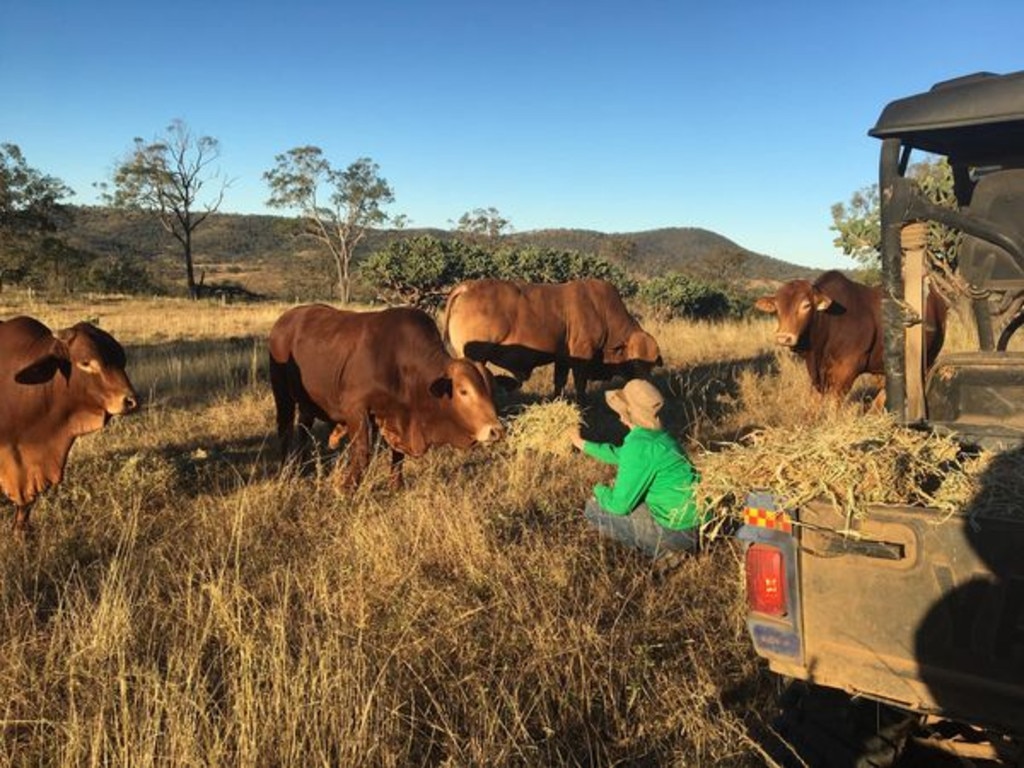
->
xmin=694 ymin=414 xmax=1024 ymax=520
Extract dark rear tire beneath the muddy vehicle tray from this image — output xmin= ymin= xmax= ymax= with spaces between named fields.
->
xmin=770 ymin=682 xmax=918 ymax=768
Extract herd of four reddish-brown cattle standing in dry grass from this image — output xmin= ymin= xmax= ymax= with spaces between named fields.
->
xmin=0 ymin=271 xmax=945 ymax=532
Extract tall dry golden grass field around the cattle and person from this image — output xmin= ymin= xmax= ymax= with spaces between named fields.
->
xmin=0 ymin=293 xmax=884 ymax=766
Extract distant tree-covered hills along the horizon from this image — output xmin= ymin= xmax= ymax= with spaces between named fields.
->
xmin=66 ymin=206 xmax=819 ymax=292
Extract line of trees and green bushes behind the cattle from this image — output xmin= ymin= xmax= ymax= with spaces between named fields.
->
xmin=9 ymin=114 xmax=942 ymax=317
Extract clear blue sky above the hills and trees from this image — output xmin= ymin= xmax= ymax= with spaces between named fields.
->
xmin=0 ymin=0 xmax=1024 ymax=268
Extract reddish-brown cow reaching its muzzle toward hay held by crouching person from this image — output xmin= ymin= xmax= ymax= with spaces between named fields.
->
xmin=269 ymin=304 xmax=504 ymax=487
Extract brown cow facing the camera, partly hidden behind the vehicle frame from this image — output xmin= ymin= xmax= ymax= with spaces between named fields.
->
xmin=755 ymin=269 xmax=946 ymax=397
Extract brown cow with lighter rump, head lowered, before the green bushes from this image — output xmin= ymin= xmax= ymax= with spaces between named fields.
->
xmin=444 ymin=280 xmax=662 ymax=399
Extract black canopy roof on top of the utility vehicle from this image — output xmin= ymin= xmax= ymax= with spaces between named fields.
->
xmin=868 ymin=71 xmax=1024 ymax=165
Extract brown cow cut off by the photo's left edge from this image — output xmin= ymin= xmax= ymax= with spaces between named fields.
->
xmin=0 ymin=317 xmax=138 ymax=532
